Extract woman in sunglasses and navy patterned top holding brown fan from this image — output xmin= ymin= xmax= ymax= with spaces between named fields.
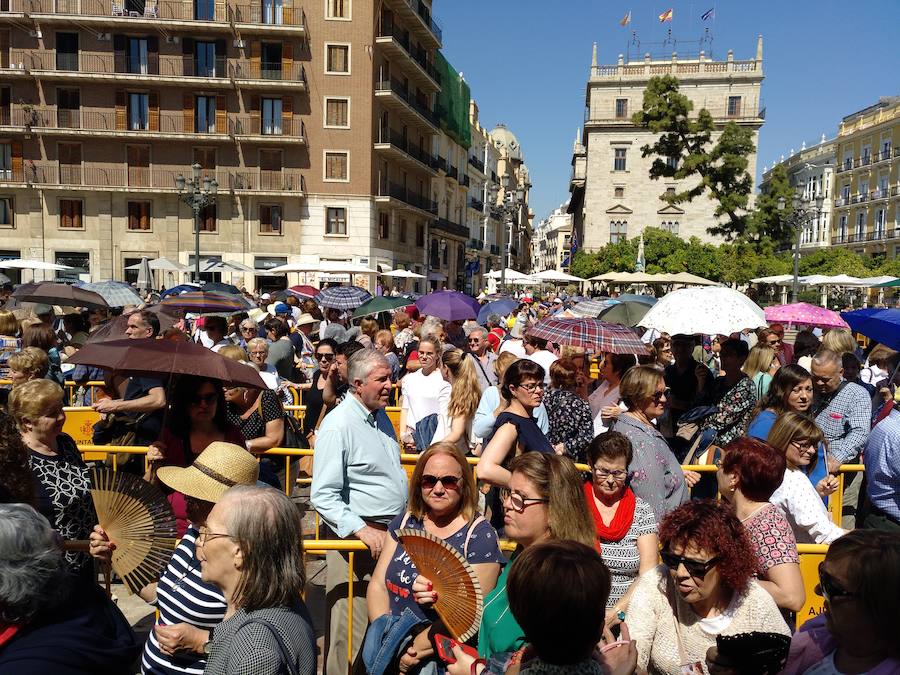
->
xmin=363 ymin=443 xmax=506 ymax=671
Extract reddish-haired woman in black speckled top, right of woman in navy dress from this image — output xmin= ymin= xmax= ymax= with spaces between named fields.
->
xmin=543 ymin=358 xmax=594 ymax=462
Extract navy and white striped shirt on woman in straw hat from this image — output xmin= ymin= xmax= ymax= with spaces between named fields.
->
xmin=141 ymin=525 xmax=226 ymax=675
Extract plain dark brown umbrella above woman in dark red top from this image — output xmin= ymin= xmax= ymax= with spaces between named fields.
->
xmin=68 ymin=339 xmax=266 ymax=389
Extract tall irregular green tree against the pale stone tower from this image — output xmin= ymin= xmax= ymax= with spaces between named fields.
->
xmin=632 ymin=75 xmax=755 ymax=240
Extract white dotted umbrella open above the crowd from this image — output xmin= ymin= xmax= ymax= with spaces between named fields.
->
xmin=638 ymin=286 xmax=767 ymax=335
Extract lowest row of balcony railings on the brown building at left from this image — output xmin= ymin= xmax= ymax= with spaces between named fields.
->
xmin=7 ymin=160 xmax=306 ymax=192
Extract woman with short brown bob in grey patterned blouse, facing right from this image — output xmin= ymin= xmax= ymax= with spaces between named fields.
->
xmin=613 ymin=365 xmax=697 ymax=522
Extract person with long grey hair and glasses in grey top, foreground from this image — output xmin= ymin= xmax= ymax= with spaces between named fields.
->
xmin=197 ymin=485 xmax=316 ymax=675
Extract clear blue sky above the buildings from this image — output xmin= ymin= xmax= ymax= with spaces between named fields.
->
xmin=434 ymin=0 xmax=900 ymax=220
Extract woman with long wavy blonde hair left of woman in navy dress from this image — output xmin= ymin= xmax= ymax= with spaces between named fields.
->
xmin=431 ymin=349 xmax=481 ymax=454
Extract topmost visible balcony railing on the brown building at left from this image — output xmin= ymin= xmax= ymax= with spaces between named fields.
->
xmin=8 ymin=0 xmax=306 ymax=28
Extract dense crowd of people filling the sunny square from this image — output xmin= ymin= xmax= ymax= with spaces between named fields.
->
xmin=0 ymin=286 xmax=900 ymax=675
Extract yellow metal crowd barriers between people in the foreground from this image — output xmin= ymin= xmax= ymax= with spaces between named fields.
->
xmin=79 ymin=445 xmax=852 ymax=663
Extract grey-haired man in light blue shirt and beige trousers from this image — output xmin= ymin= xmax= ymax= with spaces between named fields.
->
xmin=310 ymin=349 xmax=408 ymax=675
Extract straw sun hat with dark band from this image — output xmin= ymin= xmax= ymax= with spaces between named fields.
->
xmin=156 ymin=441 xmax=259 ymax=502
